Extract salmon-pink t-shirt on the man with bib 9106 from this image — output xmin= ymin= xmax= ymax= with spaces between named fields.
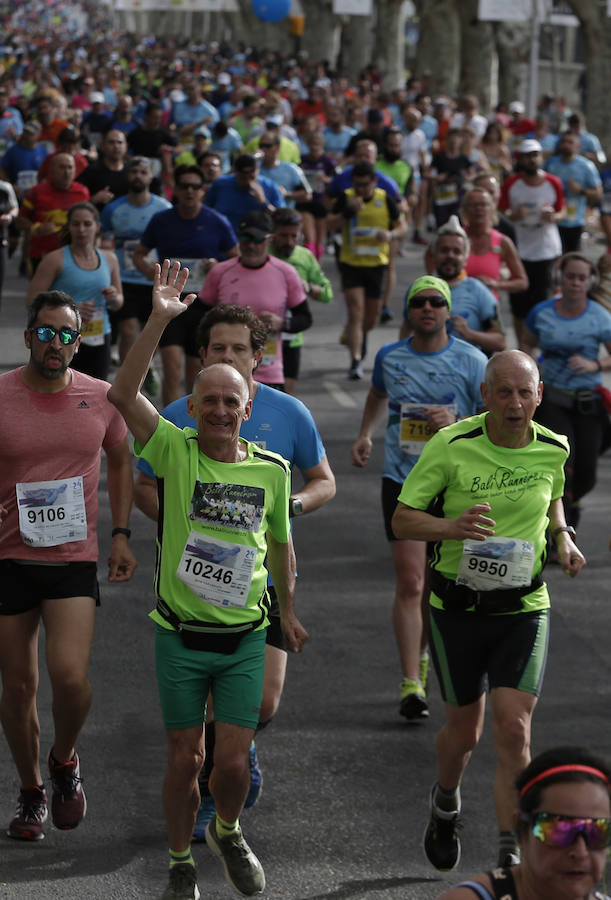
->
xmin=0 ymin=368 xmax=127 ymax=562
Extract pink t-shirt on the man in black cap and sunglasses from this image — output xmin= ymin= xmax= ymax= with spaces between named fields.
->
xmin=199 ymin=256 xmax=305 ymax=384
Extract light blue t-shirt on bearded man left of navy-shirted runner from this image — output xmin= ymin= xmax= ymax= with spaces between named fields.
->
xmin=100 ymin=194 xmax=172 ymax=284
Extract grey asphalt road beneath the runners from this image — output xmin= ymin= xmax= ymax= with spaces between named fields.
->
xmin=0 ymin=236 xmax=611 ymax=900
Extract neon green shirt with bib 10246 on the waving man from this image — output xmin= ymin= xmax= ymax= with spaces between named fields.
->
xmin=134 ymin=416 xmax=291 ymax=628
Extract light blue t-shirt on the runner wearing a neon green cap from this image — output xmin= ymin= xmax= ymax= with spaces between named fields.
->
xmin=371 ymin=337 xmax=488 ymax=484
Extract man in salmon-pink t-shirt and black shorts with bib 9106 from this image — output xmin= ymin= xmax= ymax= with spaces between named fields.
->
xmin=0 ymin=291 xmax=136 ymax=841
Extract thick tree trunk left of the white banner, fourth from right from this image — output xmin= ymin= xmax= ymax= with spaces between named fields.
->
xmin=413 ymin=0 xmax=461 ymax=95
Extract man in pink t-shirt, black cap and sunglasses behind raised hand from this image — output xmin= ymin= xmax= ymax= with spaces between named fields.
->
xmin=199 ymin=210 xmax=312 ymax=390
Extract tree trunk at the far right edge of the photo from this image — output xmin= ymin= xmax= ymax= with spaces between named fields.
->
xmin=568 ymin=0 xmax=611 ymax=155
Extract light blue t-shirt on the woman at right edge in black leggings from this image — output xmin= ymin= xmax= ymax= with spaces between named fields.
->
xmin=525 ymin=298 xmax=611 ymax=391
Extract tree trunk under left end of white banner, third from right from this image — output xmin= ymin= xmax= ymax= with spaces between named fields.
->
xmin=458 ymin=0 xmax=494 ymax=115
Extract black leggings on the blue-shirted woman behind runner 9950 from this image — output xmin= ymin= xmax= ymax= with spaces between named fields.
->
xmin=535 ymin=394 xmax=607 ymax=525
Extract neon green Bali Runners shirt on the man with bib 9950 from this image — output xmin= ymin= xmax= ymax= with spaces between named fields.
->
xmin=398 ymin=413 xmax=569 ymax=612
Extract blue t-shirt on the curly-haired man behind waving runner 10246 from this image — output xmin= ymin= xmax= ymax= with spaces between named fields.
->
xmin=137 ymin=382 xmax=325 ymax=478
